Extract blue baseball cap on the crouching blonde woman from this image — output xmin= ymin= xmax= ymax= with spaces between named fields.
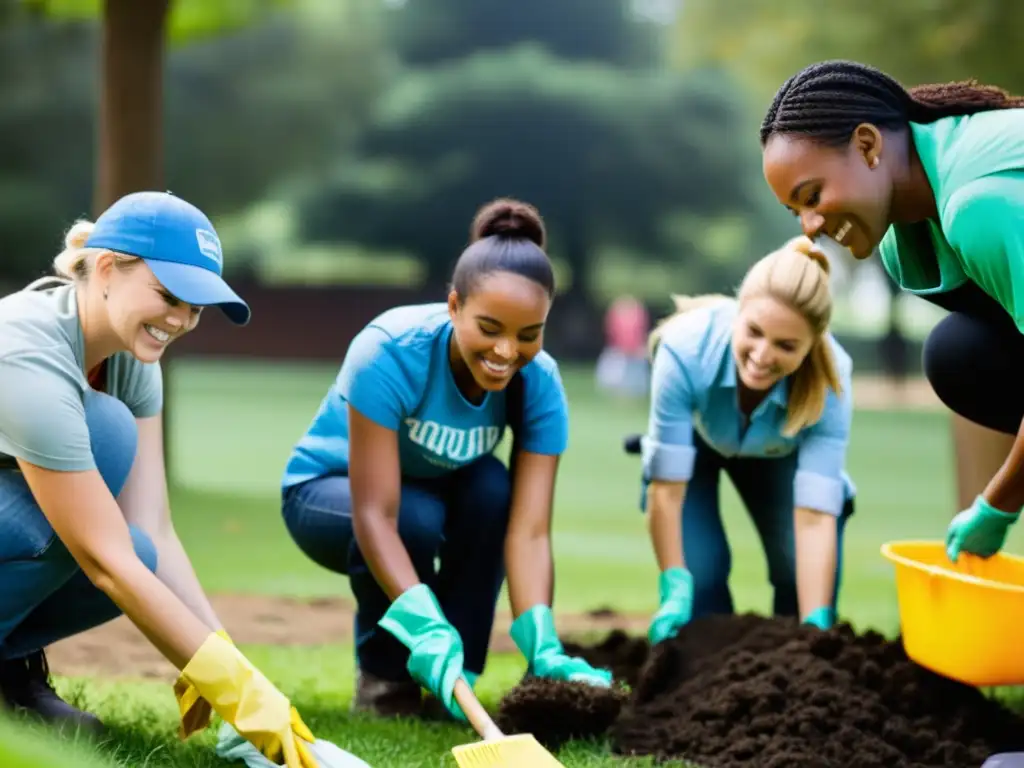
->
xmin=85 ymin=191 xmax=250 ymax=326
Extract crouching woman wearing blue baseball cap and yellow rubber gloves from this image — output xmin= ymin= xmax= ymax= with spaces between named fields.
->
xmin=0 ymin=193 xmax=315 ymax=768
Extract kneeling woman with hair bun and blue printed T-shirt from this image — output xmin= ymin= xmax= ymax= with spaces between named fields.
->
xmin=283 ymin=200 xmax=609 ymax=718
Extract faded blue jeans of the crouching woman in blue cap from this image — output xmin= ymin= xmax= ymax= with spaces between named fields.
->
xmin=0 ymin=391 xmax=157 ymax=658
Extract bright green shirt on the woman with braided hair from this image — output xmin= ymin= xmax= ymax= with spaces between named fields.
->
xmin=879 ymin=110 xmax=1024 ymax=332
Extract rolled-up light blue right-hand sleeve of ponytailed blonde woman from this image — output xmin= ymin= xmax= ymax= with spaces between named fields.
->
xmin=794 ymin=364 xmax=853 ymax=517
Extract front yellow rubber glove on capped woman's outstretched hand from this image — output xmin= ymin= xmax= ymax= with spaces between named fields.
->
xmin=181 ymin=632 xmax=318 ymax=768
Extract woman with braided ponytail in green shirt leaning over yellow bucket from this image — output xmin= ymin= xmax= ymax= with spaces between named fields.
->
xmin=761 ymin=61 xmax=1024 ymax=560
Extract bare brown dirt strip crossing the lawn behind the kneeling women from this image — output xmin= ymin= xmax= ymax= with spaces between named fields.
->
xmin=47 ymin=595 xmax=650 ymax=680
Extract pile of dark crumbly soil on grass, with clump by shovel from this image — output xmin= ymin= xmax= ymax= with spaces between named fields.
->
xmin=493 ymin=614 xmax=1024 ymax=768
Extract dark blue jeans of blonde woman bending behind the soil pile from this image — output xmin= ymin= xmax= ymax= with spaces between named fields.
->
xmin=683 ymin=433 xmax=853 ymax=618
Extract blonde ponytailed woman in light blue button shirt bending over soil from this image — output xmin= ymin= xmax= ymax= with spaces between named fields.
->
xmin=640 ymin=237 xmax=854 ymax=643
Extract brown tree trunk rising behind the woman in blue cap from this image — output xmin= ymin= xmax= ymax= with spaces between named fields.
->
xmin=92 ymin=0 xmax=171 ymax=468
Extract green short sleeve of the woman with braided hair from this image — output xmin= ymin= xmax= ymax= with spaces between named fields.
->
xmin=942 ymin=173 xmax=1024 ymax=332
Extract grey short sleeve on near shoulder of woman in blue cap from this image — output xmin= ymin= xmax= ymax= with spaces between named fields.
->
xmin=0 ymin=353 xmax=96 ymax=472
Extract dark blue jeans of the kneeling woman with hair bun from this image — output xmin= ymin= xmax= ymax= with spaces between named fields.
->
xmin=283 ymin=456 xmax=512 ymax=682
